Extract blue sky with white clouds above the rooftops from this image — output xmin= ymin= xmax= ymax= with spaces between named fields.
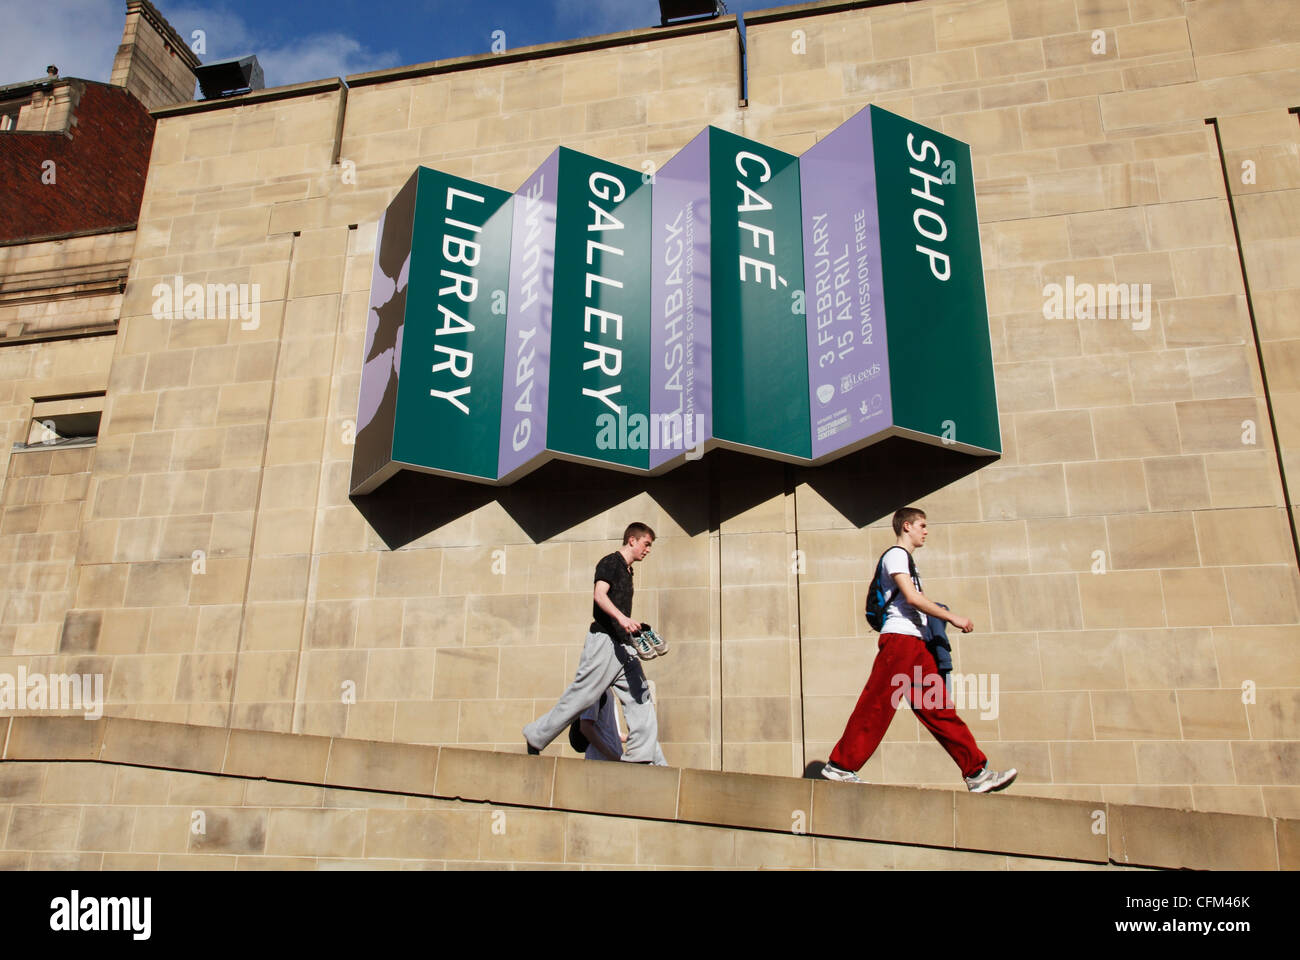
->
xmin=0 ymin=0 xmax=811 ymax=86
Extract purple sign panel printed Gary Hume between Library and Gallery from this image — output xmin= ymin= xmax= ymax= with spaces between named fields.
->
xmin=497 ymin=151 xmax=559 ymax=480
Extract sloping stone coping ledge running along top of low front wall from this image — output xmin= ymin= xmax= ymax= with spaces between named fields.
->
xmin=0 ymin=715 xmax=1300 ymax=870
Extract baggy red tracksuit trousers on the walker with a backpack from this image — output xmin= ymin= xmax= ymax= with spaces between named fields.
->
xmin=831 ymin=633 xmax=988 ymax=777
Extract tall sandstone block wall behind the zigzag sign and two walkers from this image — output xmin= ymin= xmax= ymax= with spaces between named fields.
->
xmin=0 ymin=0 xmax=1300 ymax=816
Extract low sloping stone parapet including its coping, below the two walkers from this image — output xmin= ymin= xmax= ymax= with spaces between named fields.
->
xmin=0 ymin=715 xmax=1300 ymax=870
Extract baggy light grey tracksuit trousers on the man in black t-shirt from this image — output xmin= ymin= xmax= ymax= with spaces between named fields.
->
xmin=524 ymin=633 xmax=663 ymax=764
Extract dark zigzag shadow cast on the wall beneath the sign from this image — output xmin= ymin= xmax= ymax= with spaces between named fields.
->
xmin=351 ymin=437 xmax=997 ymax=550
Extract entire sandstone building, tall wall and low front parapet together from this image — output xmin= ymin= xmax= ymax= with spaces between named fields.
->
xmin=0 ymin=0 xmax=1300 ymax=868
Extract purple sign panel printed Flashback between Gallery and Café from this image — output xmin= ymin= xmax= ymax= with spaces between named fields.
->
xmin=650 ymin=130 xmax=712 ymax=470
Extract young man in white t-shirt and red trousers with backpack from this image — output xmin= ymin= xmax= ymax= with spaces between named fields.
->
xmin=822 ymin=507 xmax=1017 ymax=793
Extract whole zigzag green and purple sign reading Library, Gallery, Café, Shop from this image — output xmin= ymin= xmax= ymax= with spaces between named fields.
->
xmin=351 ymin=107 xmax=1001 ymax=493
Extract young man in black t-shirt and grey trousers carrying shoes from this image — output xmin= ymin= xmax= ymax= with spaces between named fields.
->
xmin=524 ymin=523 xmax=663 ymax=764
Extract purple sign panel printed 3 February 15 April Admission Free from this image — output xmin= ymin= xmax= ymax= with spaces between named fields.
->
xmin=800 ymin=109 xmax=893 ymax=460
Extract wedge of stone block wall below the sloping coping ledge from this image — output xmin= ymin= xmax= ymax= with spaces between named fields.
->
xmin=10 ymin=762 xmax=1119 ymax=870
